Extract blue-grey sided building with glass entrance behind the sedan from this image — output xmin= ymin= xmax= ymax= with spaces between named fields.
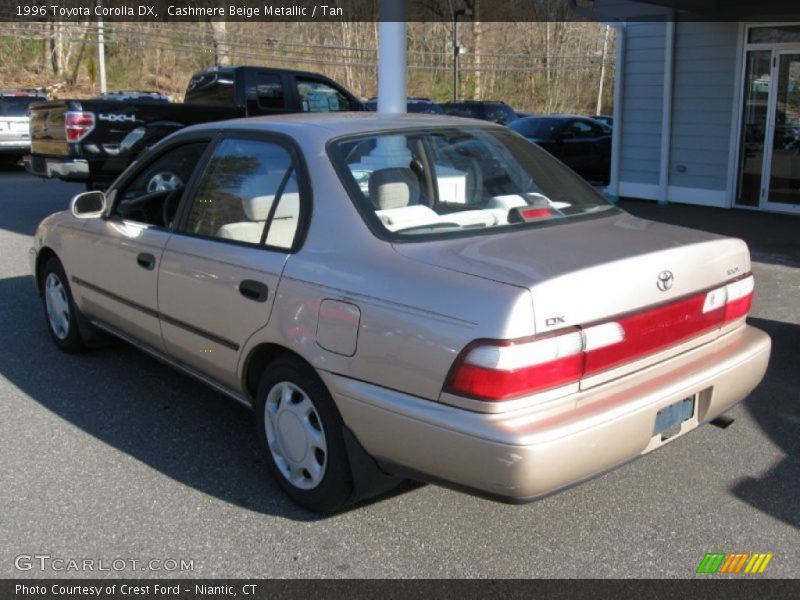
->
xmin=577 ymin=0 xmax=800 ymax=214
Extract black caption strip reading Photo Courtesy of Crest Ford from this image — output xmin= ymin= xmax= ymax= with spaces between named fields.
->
xmin=0 ymin=580 xmax=800 ymax=600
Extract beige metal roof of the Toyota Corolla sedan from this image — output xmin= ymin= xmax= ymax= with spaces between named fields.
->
xmin=182 ymin=111 xmax=504 ymax=138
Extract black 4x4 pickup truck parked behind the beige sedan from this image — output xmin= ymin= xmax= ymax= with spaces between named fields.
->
xmin=23 ymin=66 xmax=363 ymax=189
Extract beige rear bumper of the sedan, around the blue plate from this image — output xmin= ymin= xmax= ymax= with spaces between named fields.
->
xmin=322 ymin=326 xmax=771 ymax=502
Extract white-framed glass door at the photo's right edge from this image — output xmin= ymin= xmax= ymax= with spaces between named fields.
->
xmin=761 ymin=51 xmax=800 ymax=213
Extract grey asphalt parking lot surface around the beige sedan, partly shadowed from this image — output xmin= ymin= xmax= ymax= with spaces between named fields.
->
xmin=0 ymin=167 xmax=800 ymax=578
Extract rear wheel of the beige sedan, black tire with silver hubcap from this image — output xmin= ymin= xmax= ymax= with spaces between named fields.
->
xmin=256 ymin=357 xmax=356 ymax=513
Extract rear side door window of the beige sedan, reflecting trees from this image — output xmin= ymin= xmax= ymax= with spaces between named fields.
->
xmin=185 ymin=139 xmax=300 ymax=249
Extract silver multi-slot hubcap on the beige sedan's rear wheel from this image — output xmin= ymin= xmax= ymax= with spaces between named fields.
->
xmin=264 ymin=381 xmax=328 ymax=490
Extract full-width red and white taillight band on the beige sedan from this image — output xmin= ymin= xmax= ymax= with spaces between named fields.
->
xmin=444 ymin=275 xmax=753 ymax=402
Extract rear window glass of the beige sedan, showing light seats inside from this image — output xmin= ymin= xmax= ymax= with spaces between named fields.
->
xmin=331 ymin=127 xmax=616 ymax=239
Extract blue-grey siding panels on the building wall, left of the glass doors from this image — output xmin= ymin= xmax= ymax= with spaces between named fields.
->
xmin=619 ymin=21 xmax=739 ymax=204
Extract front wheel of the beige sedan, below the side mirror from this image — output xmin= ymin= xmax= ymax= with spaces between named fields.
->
xmin=42 ymin=256 xmax=86 ymax=353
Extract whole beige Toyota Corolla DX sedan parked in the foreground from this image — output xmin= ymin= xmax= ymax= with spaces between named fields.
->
xmin=31 ymin=113 xmax=770 ymax=511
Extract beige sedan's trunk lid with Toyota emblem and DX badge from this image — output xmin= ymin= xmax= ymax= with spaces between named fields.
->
xmin=395 ymin=213 xmax=750 ymax=390
